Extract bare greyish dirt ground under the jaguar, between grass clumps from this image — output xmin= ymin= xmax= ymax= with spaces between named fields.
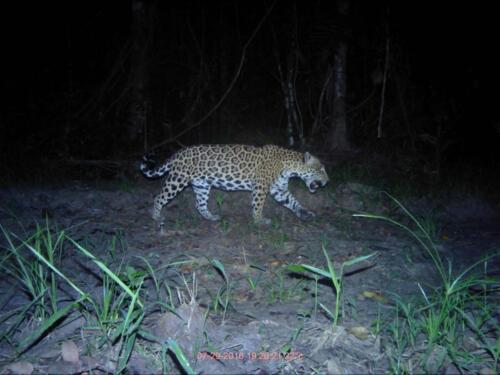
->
xmin=0 ymin=180 xmax=500 ymax=374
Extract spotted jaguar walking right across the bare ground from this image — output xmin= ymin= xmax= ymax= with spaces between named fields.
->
xmin=140 ymin=144 xmax=329 ymax=227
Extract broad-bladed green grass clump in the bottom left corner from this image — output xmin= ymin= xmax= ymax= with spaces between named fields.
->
xmin=0 ymin=221 xmax=194 ymax=374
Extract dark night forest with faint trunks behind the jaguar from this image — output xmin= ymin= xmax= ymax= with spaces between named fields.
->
xmin=0 ymin=0 xmax=500 ymax=188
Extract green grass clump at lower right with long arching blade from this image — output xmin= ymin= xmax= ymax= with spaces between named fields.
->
xmin=354 ymin=194 xmax=500 ymax=373
